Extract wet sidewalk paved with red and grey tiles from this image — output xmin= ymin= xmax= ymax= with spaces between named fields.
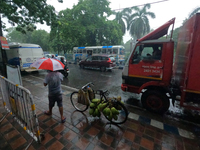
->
xmin=0 ymin=76 xmax=200 ymax=150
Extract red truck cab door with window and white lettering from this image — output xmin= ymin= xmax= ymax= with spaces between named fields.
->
xmin=128 ymin=43 xmax=163 ymax=87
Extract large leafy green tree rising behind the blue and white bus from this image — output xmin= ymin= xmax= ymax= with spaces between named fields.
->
xmin=50 ymin=0 xmax=122 ymax=53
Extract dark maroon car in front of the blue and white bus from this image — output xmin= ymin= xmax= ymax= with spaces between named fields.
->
xmin=79 ymin=55 xmax=116 ymax=72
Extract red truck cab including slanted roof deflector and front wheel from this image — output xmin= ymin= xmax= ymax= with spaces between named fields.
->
xmin=121 ymin=18 xmax=175 ymax=113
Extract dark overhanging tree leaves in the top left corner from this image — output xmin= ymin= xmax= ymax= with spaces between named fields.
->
xmin=0 ymin=0 xmax=62 ymax=36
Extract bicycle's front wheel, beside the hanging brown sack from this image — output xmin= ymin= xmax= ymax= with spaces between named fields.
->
xmin=70 ymin=92 xmax=88 ymax=112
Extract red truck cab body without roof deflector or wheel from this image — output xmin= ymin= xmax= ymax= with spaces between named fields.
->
xmin=122 ymin=40 xmax=174 ymax=93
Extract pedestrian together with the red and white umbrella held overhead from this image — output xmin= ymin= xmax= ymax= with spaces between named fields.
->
xmin=31 ymin=58 xmax=66 ymax=123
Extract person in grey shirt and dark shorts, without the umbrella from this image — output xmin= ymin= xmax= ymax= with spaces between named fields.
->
xmin=44 ymin=71 xmax=66 ymax=123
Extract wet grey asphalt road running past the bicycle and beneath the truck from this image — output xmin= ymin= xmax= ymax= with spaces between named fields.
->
xmin=22 ymin=64 xmax=200 ymax=125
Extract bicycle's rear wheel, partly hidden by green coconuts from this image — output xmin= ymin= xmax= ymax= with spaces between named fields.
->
xmin=104 ymin=101 xmax=128 ymax=124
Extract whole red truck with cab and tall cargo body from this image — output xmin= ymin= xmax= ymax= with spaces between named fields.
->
xmin=121 ymin=13 xmax=200 ymax=113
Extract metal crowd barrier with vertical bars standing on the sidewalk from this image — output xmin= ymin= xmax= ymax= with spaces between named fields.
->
xmin=0 ymin=76 xmax=43 ymax=149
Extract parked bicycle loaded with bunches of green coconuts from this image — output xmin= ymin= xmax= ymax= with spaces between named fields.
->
xmin=70 ymin=82 xmax=128 ymax=124
